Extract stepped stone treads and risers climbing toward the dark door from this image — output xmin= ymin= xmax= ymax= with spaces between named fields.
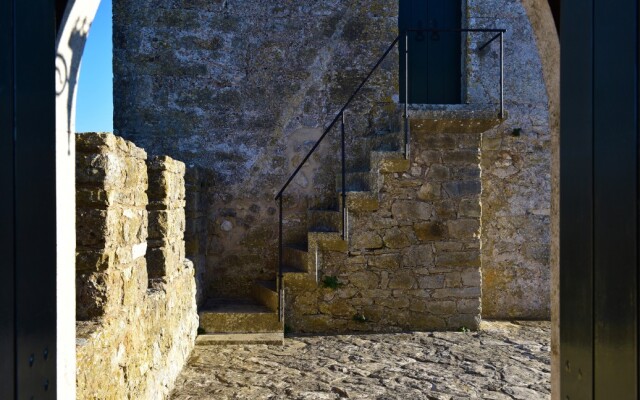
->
xmin=198 ymin=128 xmax=410 ymax=344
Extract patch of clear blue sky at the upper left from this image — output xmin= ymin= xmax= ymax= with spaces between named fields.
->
xmin=76 ymin=0 xmax=113 ymax=132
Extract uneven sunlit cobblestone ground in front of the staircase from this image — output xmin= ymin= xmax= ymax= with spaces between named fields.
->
xmin=172 ymin=322 xmax=551 ymax=400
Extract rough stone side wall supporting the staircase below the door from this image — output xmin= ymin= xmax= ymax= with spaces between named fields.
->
xmin=285 ymin=124 xmax=480 ymax=333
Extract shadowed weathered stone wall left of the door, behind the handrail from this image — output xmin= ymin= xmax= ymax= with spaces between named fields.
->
xmin=113 ymin=0 xmax=397 ymax=296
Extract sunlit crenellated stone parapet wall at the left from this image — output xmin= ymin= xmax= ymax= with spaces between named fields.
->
xmin=76 ymin=133 xmax=198 ymax=399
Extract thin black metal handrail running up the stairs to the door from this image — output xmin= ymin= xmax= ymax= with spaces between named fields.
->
xmin=275 ymin=28 xmax=506 ymax=321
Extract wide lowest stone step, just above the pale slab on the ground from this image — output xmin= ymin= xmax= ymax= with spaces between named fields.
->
xmin=198 ymin=298 xmax=284 ymax=333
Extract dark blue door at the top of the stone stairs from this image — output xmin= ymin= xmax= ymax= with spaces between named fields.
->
xmin=398 ymin=0 xmax=462 ymax=104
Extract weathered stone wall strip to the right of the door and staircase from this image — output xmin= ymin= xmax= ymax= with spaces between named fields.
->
xmin=467 ymin=0 xmax=551 ymax=319
